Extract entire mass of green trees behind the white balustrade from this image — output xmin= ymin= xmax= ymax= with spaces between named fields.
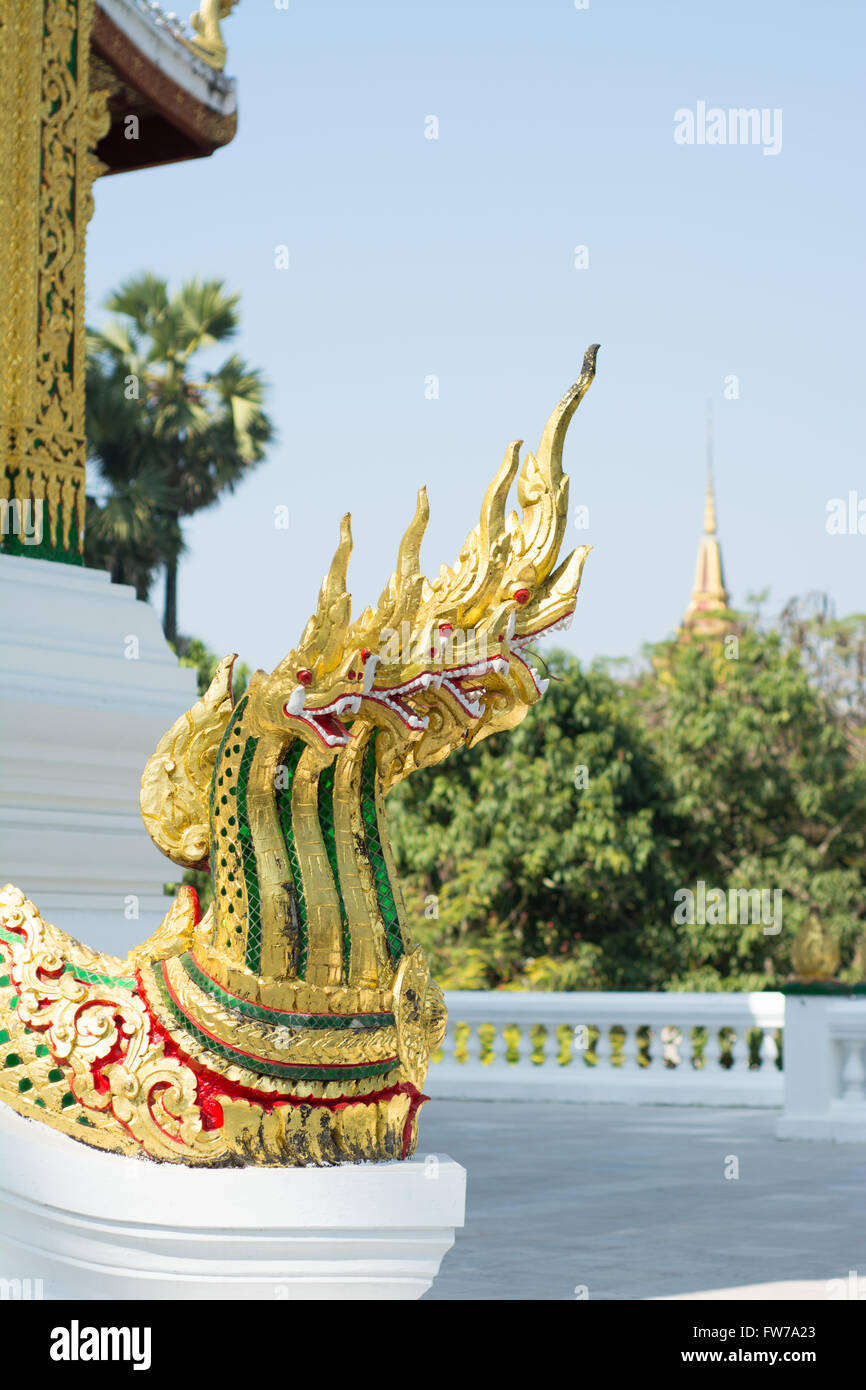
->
xmin=391 ymin=614 xmax=866 ymax=990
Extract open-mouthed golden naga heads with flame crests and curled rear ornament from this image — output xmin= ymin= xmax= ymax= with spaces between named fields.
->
xmin=142 ymin=345 xmax=598 ymax=866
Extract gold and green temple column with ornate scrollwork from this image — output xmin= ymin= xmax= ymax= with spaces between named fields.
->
xmin=0 ymin=0 xmax=108 ymax=557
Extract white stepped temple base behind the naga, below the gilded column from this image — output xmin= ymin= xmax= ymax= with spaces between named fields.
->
xmin=0 ymin=555 xmax=196 ymax=955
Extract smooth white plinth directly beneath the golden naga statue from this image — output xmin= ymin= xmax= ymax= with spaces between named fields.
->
xmin=0 ymin=1105 xmax=466 ymax=1301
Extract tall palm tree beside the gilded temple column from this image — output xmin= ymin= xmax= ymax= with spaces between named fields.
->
xmin=85 ymin=274 xmax=274 ymax=644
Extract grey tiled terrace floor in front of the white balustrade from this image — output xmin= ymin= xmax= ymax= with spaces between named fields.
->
xmin=418 ymin=1101 xmax=866 ymax=1300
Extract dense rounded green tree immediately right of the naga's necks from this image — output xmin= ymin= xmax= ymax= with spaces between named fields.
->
xmin=391 ymin=655 xmax=684 ymax=988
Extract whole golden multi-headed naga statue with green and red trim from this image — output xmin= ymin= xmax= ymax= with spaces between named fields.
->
xmin=0 ymin=346 xmax=598 ymax=1165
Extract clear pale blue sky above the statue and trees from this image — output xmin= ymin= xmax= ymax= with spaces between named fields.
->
xmin=88 ymin=0 xmax=866 ymax=666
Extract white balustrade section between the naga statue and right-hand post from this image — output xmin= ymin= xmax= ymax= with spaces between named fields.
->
xmin=425 ymin=990 xmax=789 ymax=1106
